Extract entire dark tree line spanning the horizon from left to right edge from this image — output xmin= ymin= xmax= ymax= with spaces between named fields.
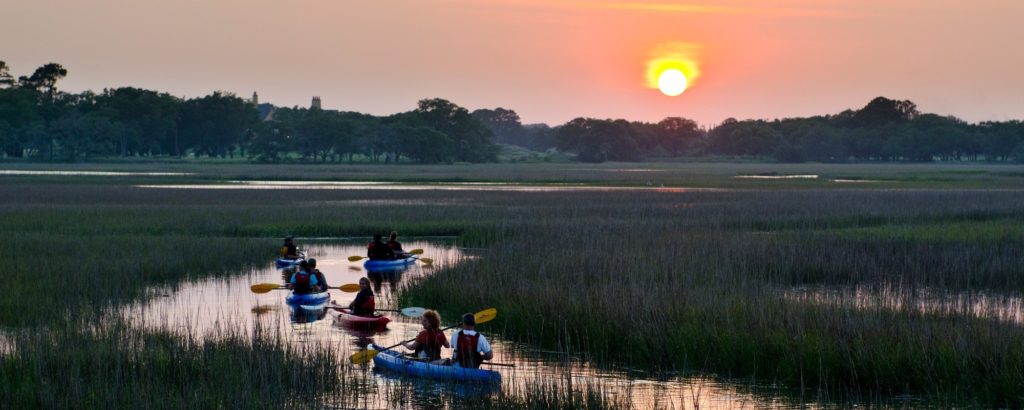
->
xmin=0 ymin=60 xmax=1024 ymax=163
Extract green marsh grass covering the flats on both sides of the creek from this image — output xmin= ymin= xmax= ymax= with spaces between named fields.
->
xmin=0 ymin=163 xmax=1024 ymax=408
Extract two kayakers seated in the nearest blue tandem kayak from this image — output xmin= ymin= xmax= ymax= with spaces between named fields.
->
xmin=402 ymin=311 xmax=494 ymax=369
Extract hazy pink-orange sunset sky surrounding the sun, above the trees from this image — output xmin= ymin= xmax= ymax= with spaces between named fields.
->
xmin=0 ymin=0 xmax=1024 ymax=126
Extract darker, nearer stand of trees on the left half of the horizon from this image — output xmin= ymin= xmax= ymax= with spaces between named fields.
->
xmin=0 ymin=62 xmax=498 ymax=163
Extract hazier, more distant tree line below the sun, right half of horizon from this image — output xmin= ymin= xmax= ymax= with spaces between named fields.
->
xmin=488 ymin=97 xmax=1024 ymax=162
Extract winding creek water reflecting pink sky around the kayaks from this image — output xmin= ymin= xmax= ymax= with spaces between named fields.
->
xmin=119 ymin=241 xmax=806 ymax=409
